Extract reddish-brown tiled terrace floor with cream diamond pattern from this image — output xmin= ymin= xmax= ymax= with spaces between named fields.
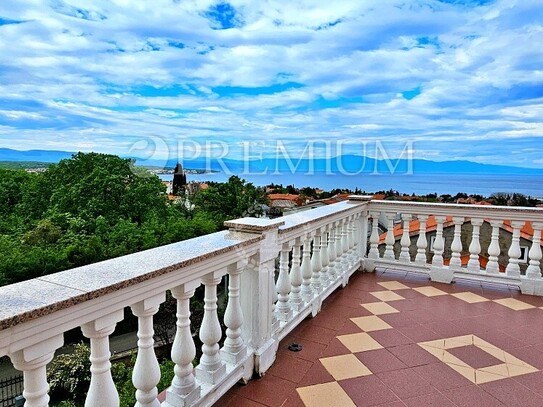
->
xmin=215 ymin=270 xmax=543 ymax=407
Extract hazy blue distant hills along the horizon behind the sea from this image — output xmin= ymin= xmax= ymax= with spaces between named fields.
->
xmin=0 ymin=148 xmax=543 ymax=175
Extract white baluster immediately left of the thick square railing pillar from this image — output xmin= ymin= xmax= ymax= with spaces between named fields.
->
xmin=221 ymin=260 xmax=247 ymax=365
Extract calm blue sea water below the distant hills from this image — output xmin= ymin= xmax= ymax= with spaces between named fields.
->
xmin=160 ymin=172 xmax=543 ymax=198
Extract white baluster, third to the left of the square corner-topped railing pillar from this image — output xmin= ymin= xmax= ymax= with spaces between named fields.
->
xmin=166 ymin=281 xmax=200 ymax=407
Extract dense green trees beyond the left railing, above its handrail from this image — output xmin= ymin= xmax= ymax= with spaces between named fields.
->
xmin=0 ymin=153 xmax=265 ymax=285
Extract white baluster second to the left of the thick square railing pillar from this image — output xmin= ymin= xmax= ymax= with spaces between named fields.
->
xmin=196 ymin=273 xmax=226 ymax=384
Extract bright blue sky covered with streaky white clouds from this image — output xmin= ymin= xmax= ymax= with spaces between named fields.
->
xmin=0 ymin=0 xmax=543 ymax=168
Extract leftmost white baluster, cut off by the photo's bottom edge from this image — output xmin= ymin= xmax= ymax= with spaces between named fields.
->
xmin=9 ymin=335 xmax=63 ymax=407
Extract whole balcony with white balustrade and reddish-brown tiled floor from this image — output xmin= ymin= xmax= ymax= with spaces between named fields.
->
xmin=0 ymin=196 xmax=543 ymax=406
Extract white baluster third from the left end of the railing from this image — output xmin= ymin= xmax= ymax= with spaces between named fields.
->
xmin=130 ymin=293 xmax=166 ymax=407
